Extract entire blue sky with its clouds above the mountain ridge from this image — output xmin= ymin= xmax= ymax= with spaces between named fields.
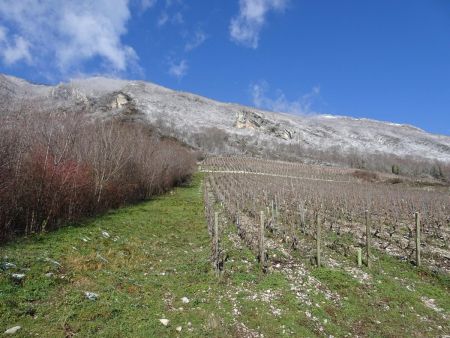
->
xmin=0 ymin=0 xmax=450 ymax=135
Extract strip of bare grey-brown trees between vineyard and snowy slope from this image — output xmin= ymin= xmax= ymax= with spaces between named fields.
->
xmin=167 ymin=121 xmax=450 ymax=183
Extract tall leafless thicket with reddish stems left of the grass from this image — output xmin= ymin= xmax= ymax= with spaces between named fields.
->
xmin=0 ymin=110 xmax=195 ymax=242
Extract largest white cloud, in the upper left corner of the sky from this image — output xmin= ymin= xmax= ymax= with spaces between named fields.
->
xmin=0 ymin=0 xmax=137 ymax=73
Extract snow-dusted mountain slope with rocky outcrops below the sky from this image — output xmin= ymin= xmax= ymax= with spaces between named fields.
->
xmin=0 ymin=75 xmax=450 ymax=162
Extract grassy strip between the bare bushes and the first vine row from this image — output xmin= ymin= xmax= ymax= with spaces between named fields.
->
xmin=0 ymin=177 xmax=215 ymax=337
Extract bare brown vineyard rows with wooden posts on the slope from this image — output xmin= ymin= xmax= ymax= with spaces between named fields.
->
xmin=201 ymin=157 xmax=450 ymax=273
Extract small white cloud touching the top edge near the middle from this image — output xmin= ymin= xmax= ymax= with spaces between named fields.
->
xmin=229 ymin=0 xmax=289 ymax=48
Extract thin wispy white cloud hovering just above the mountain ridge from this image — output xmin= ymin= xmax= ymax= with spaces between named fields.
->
xmin=250 ymin=81 xmax=320 ymax=114
